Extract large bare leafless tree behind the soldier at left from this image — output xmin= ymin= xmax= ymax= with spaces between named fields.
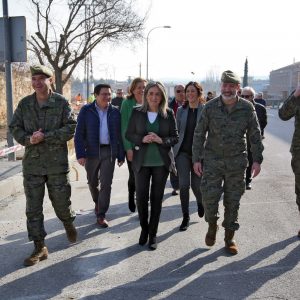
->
xmin=28 ymin=0 xmax=146 ymax=93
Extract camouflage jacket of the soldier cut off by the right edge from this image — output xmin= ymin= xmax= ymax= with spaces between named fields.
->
xmin=278 ymin=91 xmax=300 ymax=154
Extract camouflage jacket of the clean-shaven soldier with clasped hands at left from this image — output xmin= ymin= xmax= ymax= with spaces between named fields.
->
xmin=9 ymin=93 xmax=76 ymax=175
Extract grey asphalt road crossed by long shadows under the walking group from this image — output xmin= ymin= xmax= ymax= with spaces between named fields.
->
xmin=0 ymin=110 xmax=300 ymax=300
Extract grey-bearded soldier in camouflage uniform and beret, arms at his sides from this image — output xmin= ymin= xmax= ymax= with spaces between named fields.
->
xmin=193 ymin=71 xmax=263 ymax=254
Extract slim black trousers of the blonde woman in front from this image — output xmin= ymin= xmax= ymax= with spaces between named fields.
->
xmin=135 ymin=166 xmax=169 ymax=237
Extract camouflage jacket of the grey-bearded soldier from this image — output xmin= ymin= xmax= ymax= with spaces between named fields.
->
xmin=193 ymin=96 xmax=264 ymax=163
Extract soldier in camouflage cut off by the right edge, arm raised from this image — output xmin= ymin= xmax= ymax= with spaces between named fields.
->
xmin=278 ymin=86 xmax=300 ymax=237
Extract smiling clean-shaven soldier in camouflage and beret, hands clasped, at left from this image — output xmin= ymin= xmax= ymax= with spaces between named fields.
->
xmin=9 ymin=65 xmax=77 ymax=266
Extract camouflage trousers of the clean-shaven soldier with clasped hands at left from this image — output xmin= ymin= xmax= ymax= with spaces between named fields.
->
xmin=23 ymin=173 xmax=76 ymax=241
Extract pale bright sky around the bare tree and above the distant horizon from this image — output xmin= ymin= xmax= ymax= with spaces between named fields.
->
xmin=0 ymin=0 xmax=300 ymax=82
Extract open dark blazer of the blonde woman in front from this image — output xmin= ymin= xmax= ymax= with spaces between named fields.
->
xmin=126 ymin=107 xmax=178 ymax=172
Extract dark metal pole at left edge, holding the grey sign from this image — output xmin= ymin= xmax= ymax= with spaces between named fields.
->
xmin=2 ymin=0 xmax=16 ymax=161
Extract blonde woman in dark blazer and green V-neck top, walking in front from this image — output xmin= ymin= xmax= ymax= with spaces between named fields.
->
xmin=126 ymin=82 xmax=178 ymax=250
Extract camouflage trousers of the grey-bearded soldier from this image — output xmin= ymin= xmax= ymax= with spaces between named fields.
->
xmin=201 ymin=157 xmax=247 ymax=231
